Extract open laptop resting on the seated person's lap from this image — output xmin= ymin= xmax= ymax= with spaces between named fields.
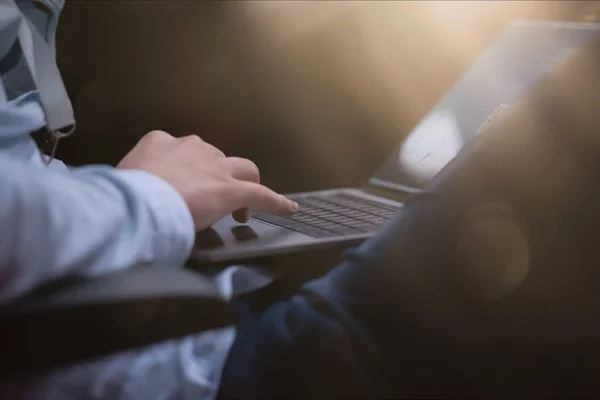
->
xmin=191 ymin=21 xmax=600 ymax=263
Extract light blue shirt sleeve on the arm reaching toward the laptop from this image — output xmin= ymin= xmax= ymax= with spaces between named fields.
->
xmin=0 ymin=155 xmax=194 ymax=302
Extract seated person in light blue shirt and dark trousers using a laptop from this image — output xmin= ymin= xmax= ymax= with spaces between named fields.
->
xmin=0 ymin=0 xmax=600 ymax=400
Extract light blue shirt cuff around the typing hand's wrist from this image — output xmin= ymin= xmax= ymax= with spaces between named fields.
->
xmin=117 ymin=170 xmax=195 ymax=266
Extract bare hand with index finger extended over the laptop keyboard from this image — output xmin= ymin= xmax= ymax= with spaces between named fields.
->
xmin=117 ymin=131 xmax=298 ymax=231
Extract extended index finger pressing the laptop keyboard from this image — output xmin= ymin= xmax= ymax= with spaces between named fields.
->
xmin=234 ymin=181 xmax=299 ymax=215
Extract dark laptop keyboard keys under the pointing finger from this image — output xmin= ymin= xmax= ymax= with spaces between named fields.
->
xmin=253 ymin=194 xmax=400 ymax=238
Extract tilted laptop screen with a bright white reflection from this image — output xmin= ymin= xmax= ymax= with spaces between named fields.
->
xmin=369 ymin=21 xmax=600 ymax=191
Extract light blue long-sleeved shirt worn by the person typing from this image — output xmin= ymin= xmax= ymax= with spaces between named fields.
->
xmin=0 ymin=0 xmax=235 ymax=400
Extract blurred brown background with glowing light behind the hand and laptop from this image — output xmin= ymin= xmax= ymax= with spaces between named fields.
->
xmin=57 ymin=0 xmax=600 ymax=192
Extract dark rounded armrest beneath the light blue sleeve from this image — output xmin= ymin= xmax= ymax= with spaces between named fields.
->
xmin=0 ymin=267 xmax=235 ymax=380
